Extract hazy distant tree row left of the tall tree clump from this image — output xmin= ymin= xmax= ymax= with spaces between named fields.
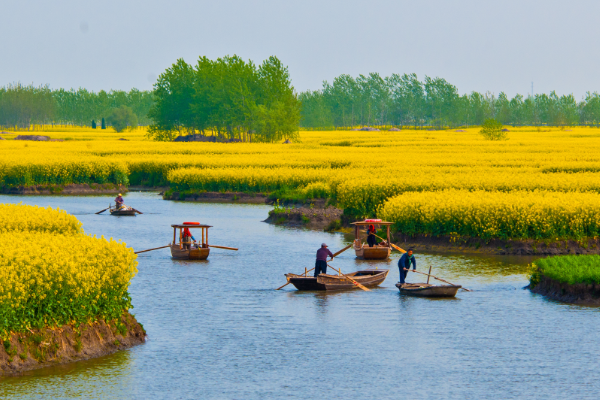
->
xmin=0 ymin=83 xmax=153 ymax=129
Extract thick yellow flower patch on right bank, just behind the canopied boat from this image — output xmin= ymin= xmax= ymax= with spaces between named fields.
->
xmin=378 ymin=189 xmax=600 ymax=240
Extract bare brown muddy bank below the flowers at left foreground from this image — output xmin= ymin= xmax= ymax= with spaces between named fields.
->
xmin=0 ymin=313 xmax=146 ymax=375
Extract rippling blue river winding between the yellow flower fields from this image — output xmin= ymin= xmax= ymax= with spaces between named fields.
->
xmin=0 ymin=192 xmax=600 ymax=399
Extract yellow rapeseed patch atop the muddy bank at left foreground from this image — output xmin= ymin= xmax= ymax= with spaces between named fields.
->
xmin=0 ymin=205 xmax=137 ymax=336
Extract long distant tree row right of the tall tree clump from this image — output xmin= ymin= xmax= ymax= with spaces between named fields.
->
xmin=299 ymin=73 xmax=600 ymax=128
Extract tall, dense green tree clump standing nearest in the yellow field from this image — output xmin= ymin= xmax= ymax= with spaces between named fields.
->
xmin=149 ymin=55 xmax=300 ymax=142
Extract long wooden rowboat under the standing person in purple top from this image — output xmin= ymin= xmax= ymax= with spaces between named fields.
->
xmin=285 ymin=269 xmax=389 ymax=290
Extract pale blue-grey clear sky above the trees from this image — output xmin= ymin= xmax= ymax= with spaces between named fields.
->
xmin=0 ymin=0 xmax=600 ymax=100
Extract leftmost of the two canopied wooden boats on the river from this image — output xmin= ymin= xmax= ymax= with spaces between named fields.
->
xmin=171 ymin=222 xmax=238 ymax=260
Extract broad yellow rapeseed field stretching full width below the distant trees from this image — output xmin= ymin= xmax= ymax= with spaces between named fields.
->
xmin=0 ymin=127 xmax=600 ymax=237
